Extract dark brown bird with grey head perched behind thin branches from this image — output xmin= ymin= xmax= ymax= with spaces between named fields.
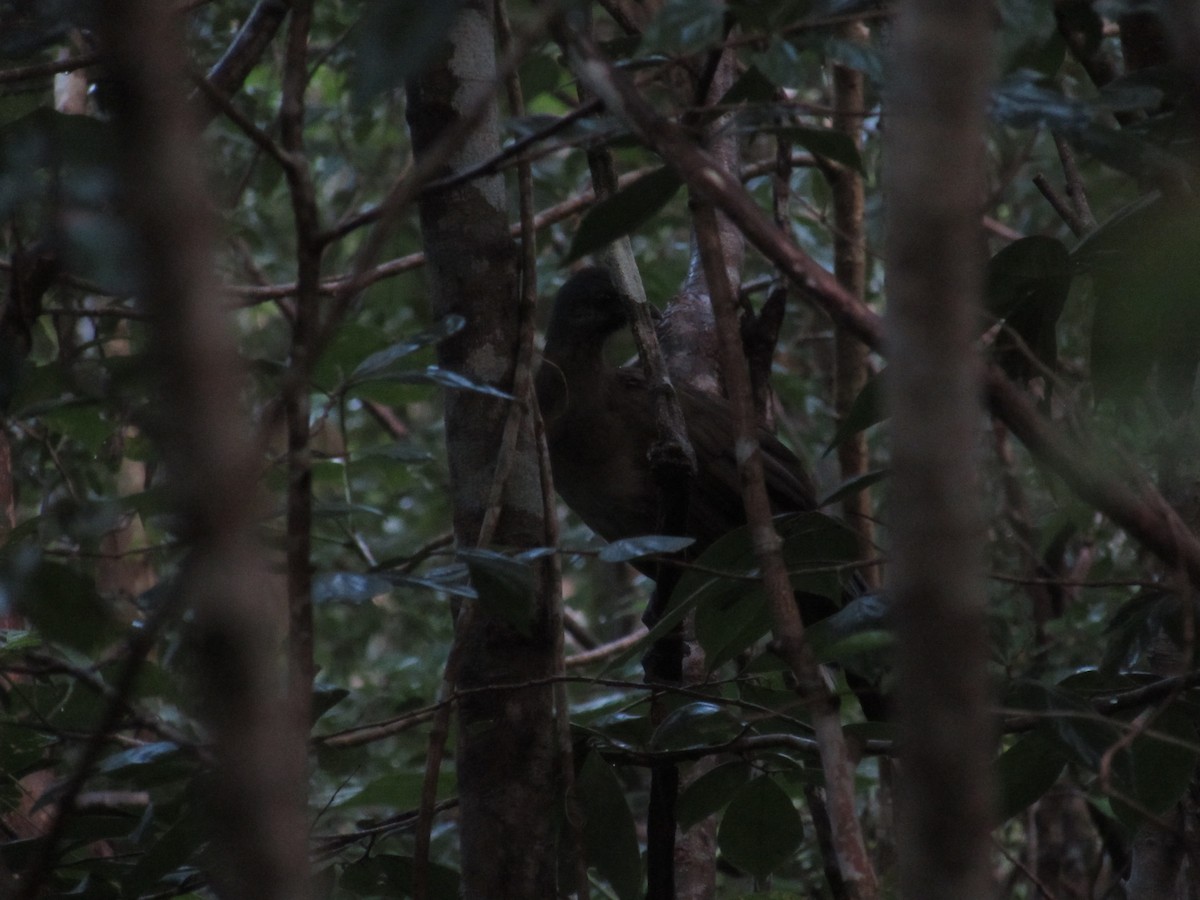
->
xmin=536 ymin=268 xmax=816 ymax=553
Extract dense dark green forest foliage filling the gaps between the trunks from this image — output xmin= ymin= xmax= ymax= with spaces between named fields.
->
xmin=0 ymin=0 xmax=1200 ymax=899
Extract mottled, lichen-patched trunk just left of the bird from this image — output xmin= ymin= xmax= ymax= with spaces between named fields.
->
xmin=408 ymin=0 xmax=558 ymax=900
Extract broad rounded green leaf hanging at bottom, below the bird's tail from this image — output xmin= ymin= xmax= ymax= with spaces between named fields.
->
xmin=716 ymin=776 xmax=804 ymax=880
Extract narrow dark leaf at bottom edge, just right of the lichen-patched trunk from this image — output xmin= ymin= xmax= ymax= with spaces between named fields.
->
xmin=575 ymin=752 xmax=642 ymax=900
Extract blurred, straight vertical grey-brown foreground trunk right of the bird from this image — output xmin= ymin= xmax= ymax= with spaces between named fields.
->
xmin=884 ymin=0 xmax=994 ymax=900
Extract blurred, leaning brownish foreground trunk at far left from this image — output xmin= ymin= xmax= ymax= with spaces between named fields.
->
xmin=100 ymin=0 xmax=311 ymax=900
